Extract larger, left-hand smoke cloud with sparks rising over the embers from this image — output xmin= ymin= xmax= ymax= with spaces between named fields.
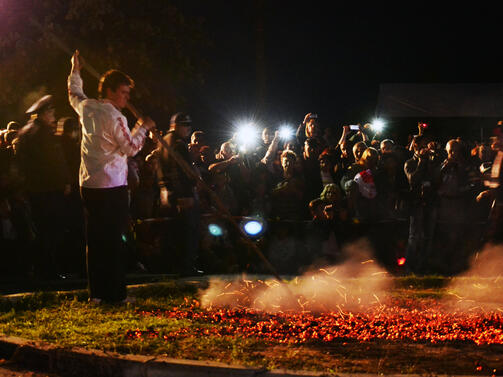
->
xmin=201 ymin=241 xmax=391 ymax=313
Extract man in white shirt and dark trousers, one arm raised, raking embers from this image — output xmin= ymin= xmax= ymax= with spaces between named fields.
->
xmin=68 ymin=51 xmax=155 ymax=302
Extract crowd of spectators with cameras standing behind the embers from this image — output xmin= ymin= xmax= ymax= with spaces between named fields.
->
xmin=0 ymin=113 xmax=501 ymax=278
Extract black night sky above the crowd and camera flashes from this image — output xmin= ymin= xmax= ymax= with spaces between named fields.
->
xmin=172 ymin=0 xmax=503 ymax=140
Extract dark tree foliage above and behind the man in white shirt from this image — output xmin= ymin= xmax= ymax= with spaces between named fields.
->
xmin=0 ymin=0 xmax=209 ymax=125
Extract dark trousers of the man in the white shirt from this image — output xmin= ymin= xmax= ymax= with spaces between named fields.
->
xmin=81 ymin=186 xmax=129 ymax=302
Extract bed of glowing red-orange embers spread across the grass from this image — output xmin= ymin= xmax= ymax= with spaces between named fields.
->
xmin=131 ymin=300 xmax=503 ymax=345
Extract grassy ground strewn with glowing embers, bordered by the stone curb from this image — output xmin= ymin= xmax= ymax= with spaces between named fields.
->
xmin=0 ymin=277 xmax=503 ymax=375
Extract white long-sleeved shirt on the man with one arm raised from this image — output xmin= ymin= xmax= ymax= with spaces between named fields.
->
xmin=68 ymin=73 xmax=146 ymax=188
